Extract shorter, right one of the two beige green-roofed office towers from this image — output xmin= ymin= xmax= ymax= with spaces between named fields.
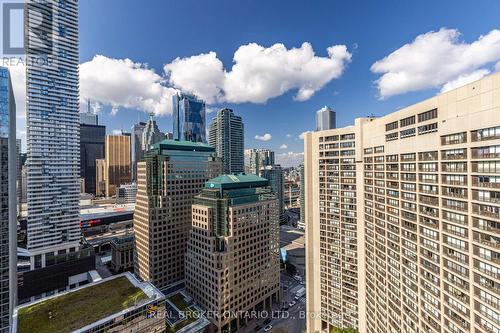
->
xmin=186 ymin=174 xmax=280 ymax=332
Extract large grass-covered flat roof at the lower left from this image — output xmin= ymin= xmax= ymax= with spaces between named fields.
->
xmin=15 ymin=273 xmax=163 ymax=333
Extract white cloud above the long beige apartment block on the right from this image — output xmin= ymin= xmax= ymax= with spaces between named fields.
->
xmin=371 ymin=28 xmax=500 ymax=99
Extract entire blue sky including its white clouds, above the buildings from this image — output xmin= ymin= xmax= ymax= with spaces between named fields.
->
xmin=13 ymin=0 xmax=500 ymax=166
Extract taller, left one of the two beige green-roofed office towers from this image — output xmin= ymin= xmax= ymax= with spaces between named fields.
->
xmin=134 ymin=140 xmax=222 ymax=289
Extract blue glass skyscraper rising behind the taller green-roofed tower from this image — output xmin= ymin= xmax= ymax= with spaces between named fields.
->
xmin=172 ymin=93 xmax=206 ymax=142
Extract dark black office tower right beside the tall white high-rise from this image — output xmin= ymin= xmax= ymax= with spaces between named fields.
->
xmin=80 ymin=113 xmax=106 ymax=194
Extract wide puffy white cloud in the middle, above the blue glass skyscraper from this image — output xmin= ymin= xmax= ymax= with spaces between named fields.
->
xmin=164 ymin=43 xmax=352 ymax=103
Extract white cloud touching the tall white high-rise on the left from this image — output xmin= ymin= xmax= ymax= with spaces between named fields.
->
xmin=80 ymin=55 xmax=176 ymax=115
